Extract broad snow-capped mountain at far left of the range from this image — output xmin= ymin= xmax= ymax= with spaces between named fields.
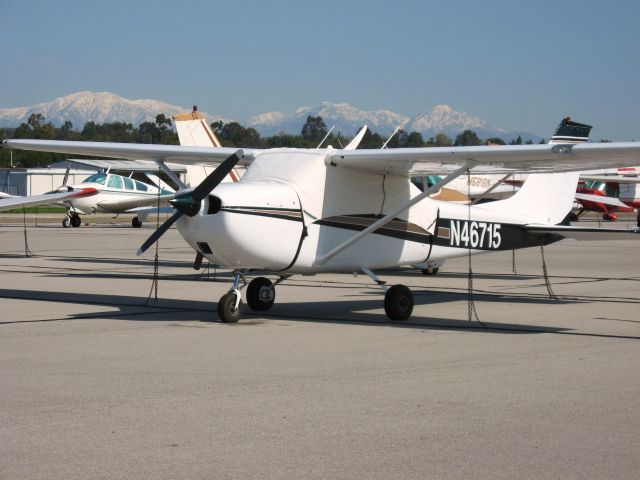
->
xmin=0 ymin=92 xmax=229 ymax=129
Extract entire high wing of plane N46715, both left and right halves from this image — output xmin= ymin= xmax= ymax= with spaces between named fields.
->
xmin=3 ymin=140 xmax=640 ymax=176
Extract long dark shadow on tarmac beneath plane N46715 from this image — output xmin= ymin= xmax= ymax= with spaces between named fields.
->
xmin=0 ymin=289 xmax=640 ymax=340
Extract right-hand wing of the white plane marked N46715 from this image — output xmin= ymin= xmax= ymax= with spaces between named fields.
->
xmin=328 ymin=142 xmax=640 ymax=176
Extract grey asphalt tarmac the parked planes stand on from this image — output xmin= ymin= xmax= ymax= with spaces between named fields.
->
xmin=0 ymin=219 xmax=640 ymax=479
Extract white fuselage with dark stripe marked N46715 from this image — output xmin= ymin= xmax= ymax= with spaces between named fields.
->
xmin=176 ymin=149 xmax=560 ymax=274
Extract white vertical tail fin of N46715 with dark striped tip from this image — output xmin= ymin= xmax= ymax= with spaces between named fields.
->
xmin=487 ymin=117 xmax=591 ymax=225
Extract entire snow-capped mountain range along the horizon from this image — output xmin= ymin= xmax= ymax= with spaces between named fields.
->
xmin=0 ymin=92 xmax=540 ymax=142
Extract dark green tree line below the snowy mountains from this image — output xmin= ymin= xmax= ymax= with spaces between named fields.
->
xmin=0 ymin=113 xmax=544 ymax=167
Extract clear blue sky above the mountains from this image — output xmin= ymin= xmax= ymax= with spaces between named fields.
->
xmin=0 ymin=0 xmax=640 ymax=141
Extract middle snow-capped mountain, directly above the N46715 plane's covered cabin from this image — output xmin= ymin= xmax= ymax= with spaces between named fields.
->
xmin=248 ymin=102 xmax=409 ymax=136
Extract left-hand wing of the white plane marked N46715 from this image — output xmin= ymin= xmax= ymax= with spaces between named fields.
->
xmin=2 ymin=140 xmax=257 ymax=165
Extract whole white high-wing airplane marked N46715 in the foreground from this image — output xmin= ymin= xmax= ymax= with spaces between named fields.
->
xmin=4 ymin=119 xmax=640 ymax=322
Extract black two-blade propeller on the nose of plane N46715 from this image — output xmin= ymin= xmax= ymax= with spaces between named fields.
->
xmin=137 ymin=150 xmax=242 ymax=256
